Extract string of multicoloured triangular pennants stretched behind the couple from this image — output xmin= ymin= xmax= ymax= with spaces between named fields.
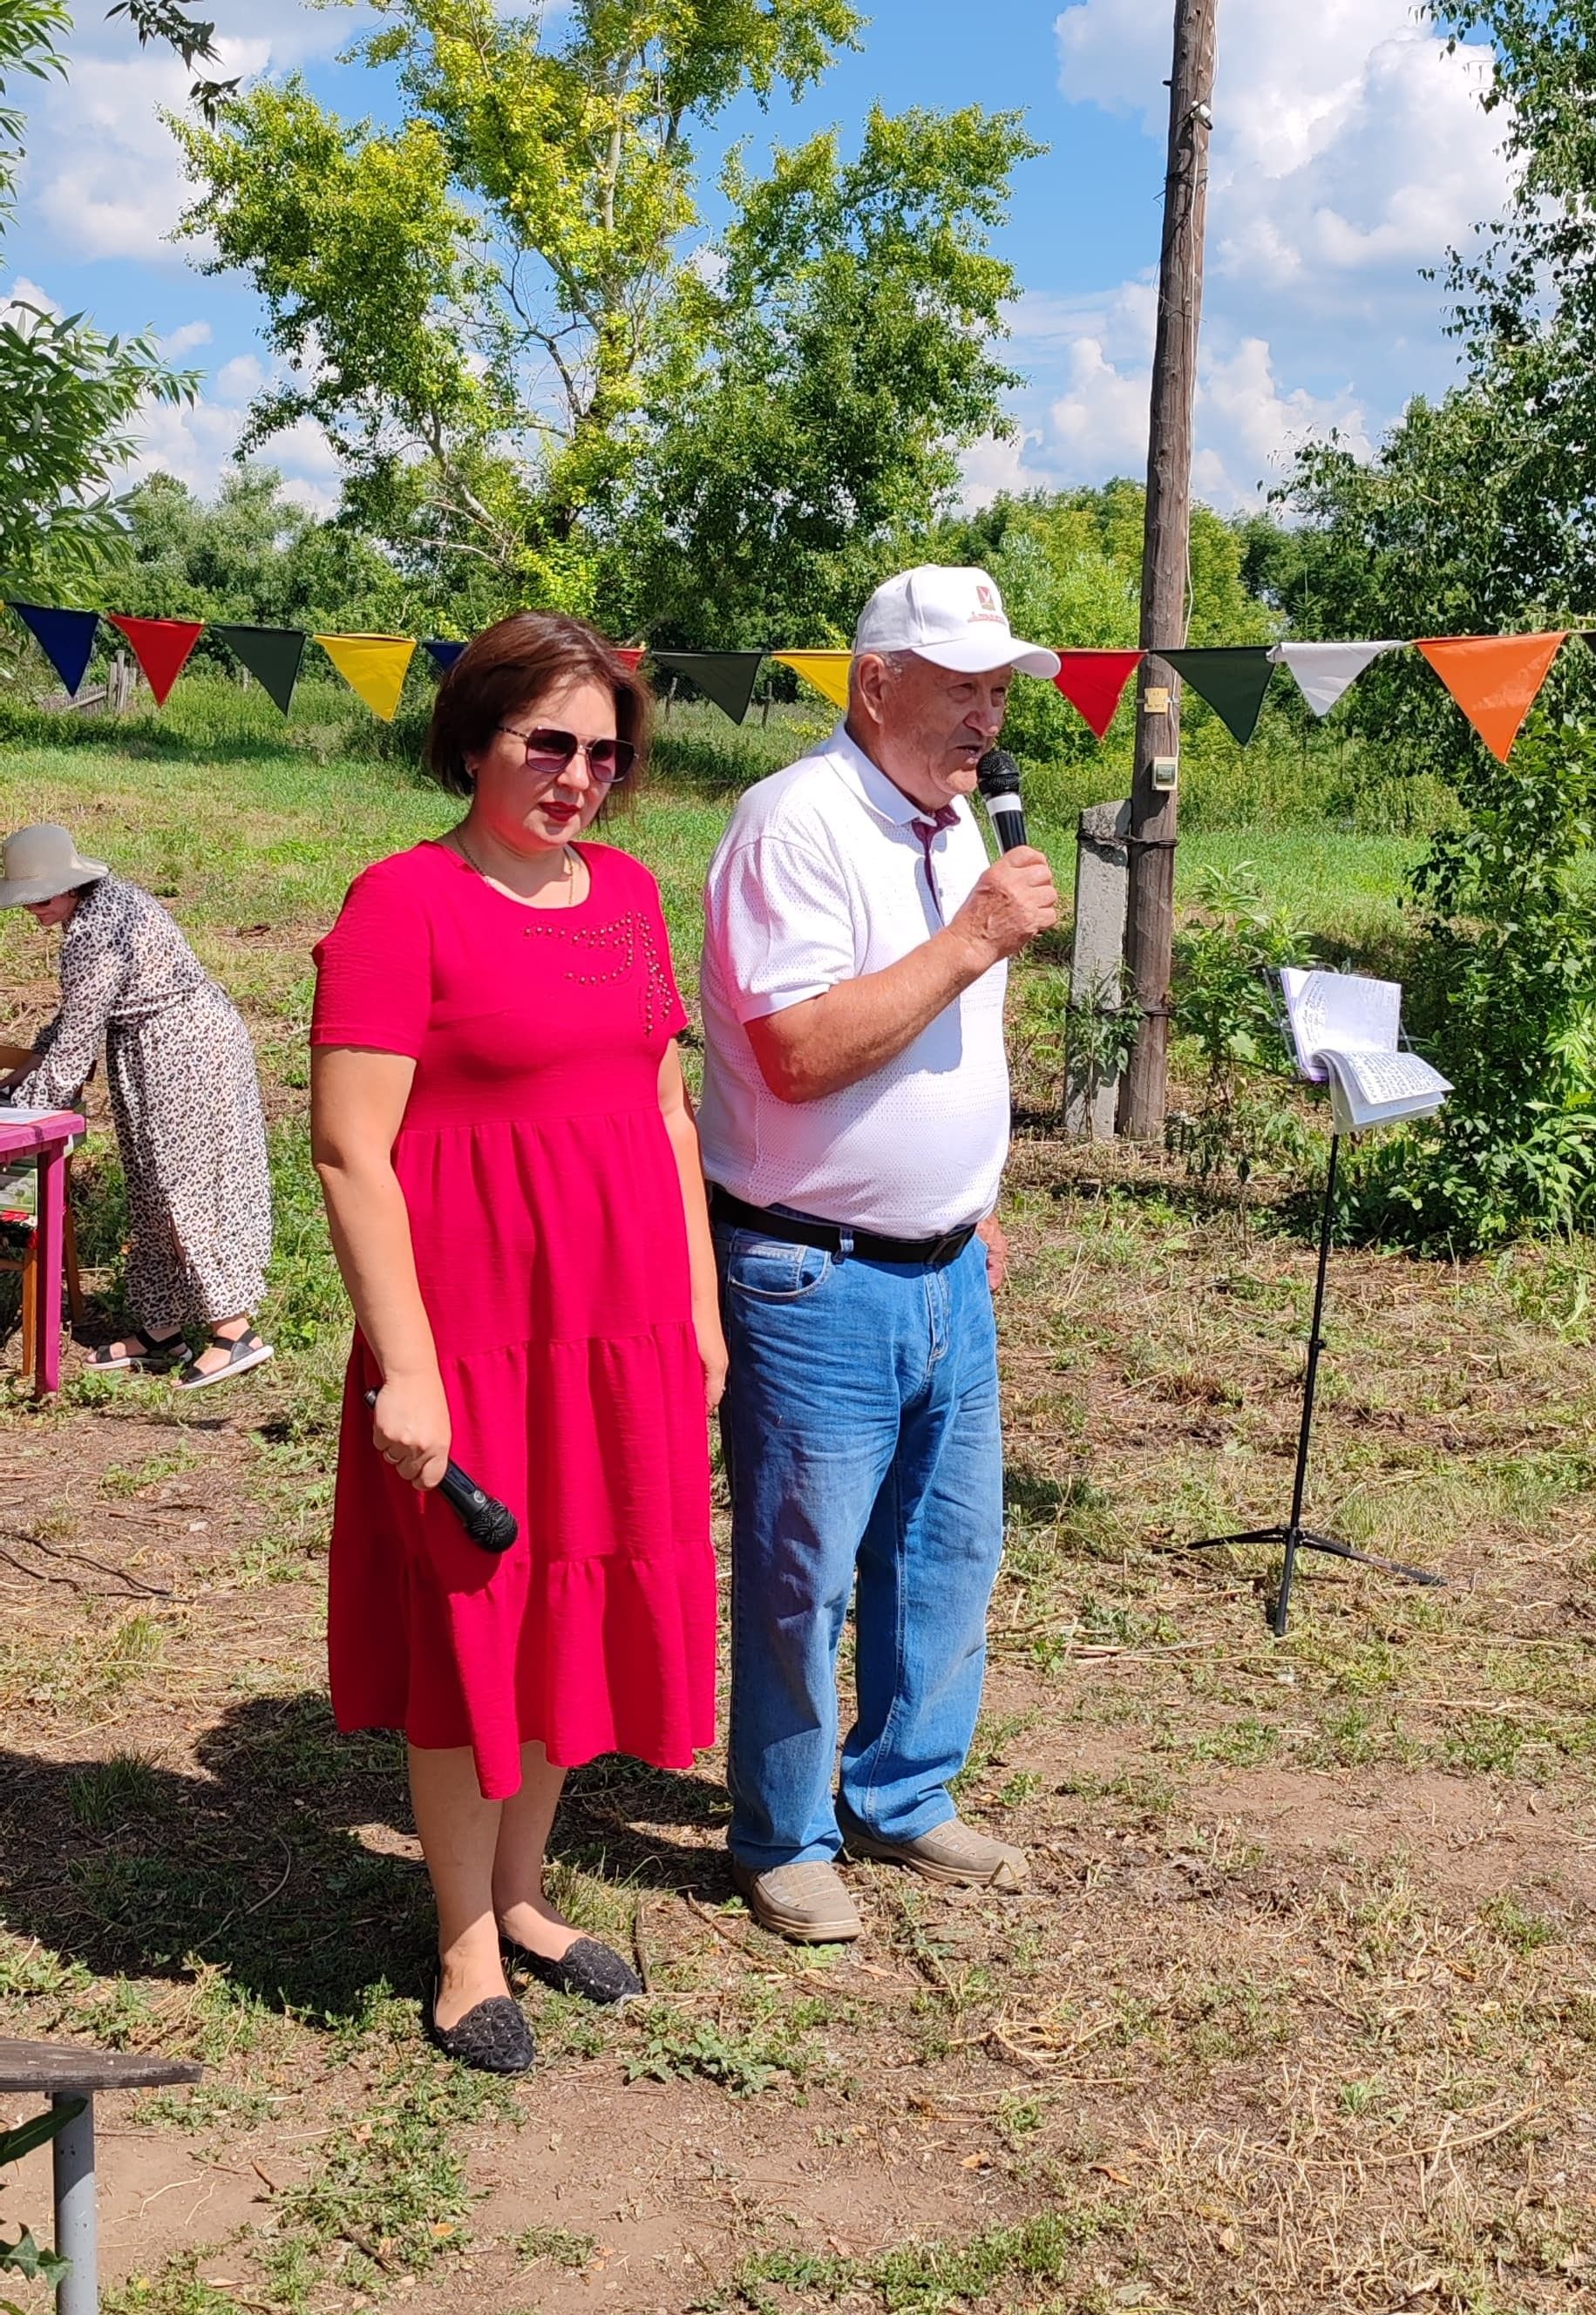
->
xmin=7 ymin=600 xmax=1565 ymax=764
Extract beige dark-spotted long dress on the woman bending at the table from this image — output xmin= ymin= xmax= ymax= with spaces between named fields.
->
xmin=11 ymin=875 xmax=271 ymax=1336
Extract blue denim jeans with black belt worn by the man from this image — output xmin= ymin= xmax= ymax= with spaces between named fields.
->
xmin=716 ymin=1225 xmax=1003 ymax=1873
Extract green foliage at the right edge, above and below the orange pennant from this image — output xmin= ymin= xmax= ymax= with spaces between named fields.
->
xmin=1253 ymin=0 xmax=1596 ymax=1250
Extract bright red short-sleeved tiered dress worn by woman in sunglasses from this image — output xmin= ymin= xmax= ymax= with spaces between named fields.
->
xmin=310 ymin=843 xmax=716 ymax=1799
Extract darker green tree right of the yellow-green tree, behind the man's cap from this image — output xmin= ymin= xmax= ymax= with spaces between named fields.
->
xmin=616 ymin=109 xmax=1036 ymax=646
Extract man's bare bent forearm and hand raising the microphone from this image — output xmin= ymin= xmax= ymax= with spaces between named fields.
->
xmin=746 ymin=847 xmax=1058 ymax=1102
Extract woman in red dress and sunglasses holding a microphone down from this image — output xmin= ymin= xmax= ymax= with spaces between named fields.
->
xmin=310 ymin=611 xmax=725 ymax=2072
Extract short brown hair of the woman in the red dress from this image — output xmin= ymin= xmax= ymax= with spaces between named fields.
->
xmin=424 ymin=611 xmax=653 ymax=801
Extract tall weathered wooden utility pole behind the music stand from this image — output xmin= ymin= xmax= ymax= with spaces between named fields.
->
xmin=1119 ymin=0 xmax=1219 ymax=1141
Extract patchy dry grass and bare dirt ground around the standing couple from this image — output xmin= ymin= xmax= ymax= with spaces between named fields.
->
xmin=0 ymin=685 xmax=1596 ymax=2315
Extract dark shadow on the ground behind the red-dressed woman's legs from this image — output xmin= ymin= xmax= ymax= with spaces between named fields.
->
xmin=0 ymin=1690 xmax=730 ymax=2021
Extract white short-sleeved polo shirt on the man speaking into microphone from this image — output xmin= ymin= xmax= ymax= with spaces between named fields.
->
xmin=700 ymin=724 xmax=1010 ymax=1239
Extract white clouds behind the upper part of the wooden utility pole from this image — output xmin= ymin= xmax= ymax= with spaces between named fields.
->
xmin=1033 ymin=0 xmax=1508 ymax=505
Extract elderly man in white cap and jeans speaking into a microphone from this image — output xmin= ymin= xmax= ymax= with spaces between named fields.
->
xmin=702 ymin=565 xmax=1058 ymax=1942
